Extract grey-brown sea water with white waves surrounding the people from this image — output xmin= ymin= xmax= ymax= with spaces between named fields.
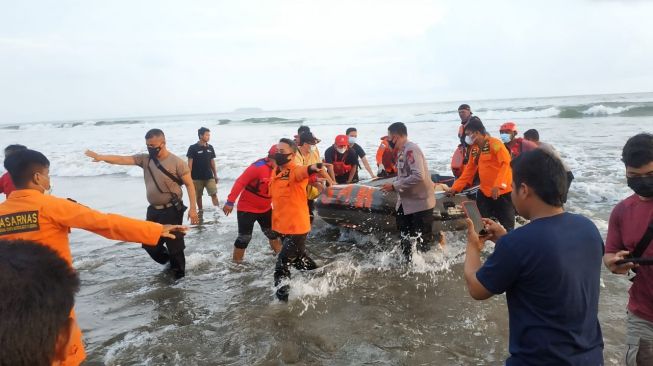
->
xmin=0 ymin=93 xmax=653 ymax=365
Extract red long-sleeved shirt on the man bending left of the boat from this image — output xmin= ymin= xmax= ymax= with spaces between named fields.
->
xmin=227 ymin=159 xmax=272 ymax=213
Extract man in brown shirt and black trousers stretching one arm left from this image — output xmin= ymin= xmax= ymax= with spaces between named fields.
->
xmin=86 ymin=129 xmax=199 ymax=278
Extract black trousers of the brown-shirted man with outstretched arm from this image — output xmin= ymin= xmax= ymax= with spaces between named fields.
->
xmin=143 ymin=206 xmax=186 ymax=277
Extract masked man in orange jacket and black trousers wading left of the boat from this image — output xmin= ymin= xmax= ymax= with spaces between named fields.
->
xmin=270 ymin=138 xmax=329 ymax=301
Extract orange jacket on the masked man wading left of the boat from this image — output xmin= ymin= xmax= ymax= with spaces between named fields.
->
xmin=270 ymin=162 xmax=311 ymax=235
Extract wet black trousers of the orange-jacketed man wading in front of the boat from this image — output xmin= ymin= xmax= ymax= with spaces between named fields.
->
xmin=274 ymin=233 xmax=317 ymax=286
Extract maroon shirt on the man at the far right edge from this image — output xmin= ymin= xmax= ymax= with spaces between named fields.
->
xmin=605 ymin=194 xmax=653 ymax=322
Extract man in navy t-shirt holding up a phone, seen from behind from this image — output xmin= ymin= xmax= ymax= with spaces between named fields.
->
xmin=464 ymin=149 xmax=603 ymax=366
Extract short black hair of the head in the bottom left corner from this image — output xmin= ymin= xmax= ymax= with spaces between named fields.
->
xmin=0 ymin=240 xmax=79 ymax=365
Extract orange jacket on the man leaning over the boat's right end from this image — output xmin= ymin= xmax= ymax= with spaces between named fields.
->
xmin=451 ymin=136 xmax=512 ymax=197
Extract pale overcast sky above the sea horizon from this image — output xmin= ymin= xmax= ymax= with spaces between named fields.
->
xmin=0 ymin=0 xmax=653 ymax=123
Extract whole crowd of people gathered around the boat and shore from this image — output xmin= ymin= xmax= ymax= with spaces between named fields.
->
xmin=0 ymin=104 xmax=653 ymax=366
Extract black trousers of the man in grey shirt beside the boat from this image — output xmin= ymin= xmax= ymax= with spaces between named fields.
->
xmin=397 ymin=206 xmax=435 ymax=261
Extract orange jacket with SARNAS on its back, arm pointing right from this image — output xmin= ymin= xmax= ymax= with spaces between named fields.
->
xmin=0 ymin=189 xmax=161 ymax=366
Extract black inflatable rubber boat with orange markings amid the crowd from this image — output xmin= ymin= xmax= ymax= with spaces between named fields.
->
xmin=315 ymin=174 xmax=478 ymax=233
